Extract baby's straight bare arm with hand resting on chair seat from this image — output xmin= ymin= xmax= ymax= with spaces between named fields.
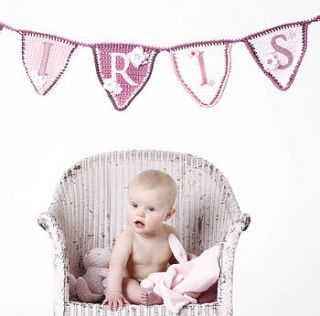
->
xmin=103 ymin=231 xmax=132 ymax=309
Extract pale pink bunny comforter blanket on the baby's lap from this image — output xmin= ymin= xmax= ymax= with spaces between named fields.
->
xmin=141 ymin=234 xmax=220 ymax=313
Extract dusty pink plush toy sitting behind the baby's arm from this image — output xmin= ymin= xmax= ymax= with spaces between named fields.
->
xmin=69 ymin=248 xmax=110 ymax=303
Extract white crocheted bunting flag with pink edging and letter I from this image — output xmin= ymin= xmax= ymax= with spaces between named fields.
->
xmin=171 ymin=42 xmax=232 ymax=107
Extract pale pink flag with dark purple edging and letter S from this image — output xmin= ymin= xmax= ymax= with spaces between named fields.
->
xmin=245 ymin=23 xmax=308 ymax=90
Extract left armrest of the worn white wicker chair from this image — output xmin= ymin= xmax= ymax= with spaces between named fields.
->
xmin=38 ymin=212 xmax=69 ymax=316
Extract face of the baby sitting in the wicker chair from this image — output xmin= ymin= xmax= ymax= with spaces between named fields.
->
xmin=127 ymin=185 xmax=172 ymax=234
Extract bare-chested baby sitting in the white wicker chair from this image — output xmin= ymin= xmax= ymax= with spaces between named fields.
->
xmin=103 ymin=170 xmax=192 ymax=309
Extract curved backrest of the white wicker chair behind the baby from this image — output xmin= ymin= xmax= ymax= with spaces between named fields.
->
xmin=52 ymin=151 xmax=240 ymax=276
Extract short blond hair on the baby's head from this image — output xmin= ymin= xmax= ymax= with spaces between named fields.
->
xmin=129 ymin=169 xmax=177 ymax=206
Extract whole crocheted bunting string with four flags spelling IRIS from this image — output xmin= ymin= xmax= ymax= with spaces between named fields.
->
xmin=0 ymin=15 xmax=320 ymax=111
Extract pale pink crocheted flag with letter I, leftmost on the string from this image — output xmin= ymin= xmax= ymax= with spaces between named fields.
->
xmin=22 ymin=32 xmax=77 ymax=95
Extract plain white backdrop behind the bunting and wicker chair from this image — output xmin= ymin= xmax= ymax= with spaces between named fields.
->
xmin=0 ymin=0 xmax=320 ymax=316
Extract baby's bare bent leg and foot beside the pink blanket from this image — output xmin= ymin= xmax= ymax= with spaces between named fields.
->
xmin=122 ymin=278 xmax=163 ymax=305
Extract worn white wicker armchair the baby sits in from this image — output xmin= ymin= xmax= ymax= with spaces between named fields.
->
xmin=38 ymin=151 xmax=250 ymax=316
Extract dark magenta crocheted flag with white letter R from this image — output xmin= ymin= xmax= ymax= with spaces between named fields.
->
xmin=93 ymin=44 xmax=159 ymax=111
